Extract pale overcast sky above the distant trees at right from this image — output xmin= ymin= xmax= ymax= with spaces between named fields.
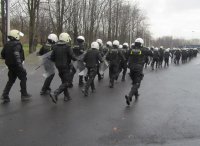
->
xmin=133 ymin=0 xmax=200 ymax=39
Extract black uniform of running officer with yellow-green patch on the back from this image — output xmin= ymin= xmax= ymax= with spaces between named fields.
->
xmin=125 ymin=43 xmax=152 ymax=105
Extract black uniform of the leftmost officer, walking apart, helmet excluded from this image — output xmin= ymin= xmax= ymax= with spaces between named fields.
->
xmin=1 ymin=40 xmax=30 ymax=102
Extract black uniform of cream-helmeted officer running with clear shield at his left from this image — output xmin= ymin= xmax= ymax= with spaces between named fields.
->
xmin=51 ymin=41 xmax=77 ymax=103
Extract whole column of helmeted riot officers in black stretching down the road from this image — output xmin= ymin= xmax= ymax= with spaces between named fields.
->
xmin=1 ymin=30 xmax=198 ymax=105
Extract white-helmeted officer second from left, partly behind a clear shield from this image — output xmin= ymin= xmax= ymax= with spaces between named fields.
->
xmin=37 ymin=34 xmax=58 ymax=95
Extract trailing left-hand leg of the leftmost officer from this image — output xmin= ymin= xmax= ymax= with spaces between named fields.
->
xmin=2 ymin=69 xmax=17 ymax=103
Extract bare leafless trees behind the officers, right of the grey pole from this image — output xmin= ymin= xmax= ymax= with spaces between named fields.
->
xmin=2 ymin=0 xmax=151 ymax=53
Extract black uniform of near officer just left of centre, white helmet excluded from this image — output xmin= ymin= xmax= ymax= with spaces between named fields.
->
xmin=83 ymin=49 xmax=103 ymax=96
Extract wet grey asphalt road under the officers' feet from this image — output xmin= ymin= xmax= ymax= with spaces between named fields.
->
xmin=0 ymin=58 xmax=200 ymax=146
